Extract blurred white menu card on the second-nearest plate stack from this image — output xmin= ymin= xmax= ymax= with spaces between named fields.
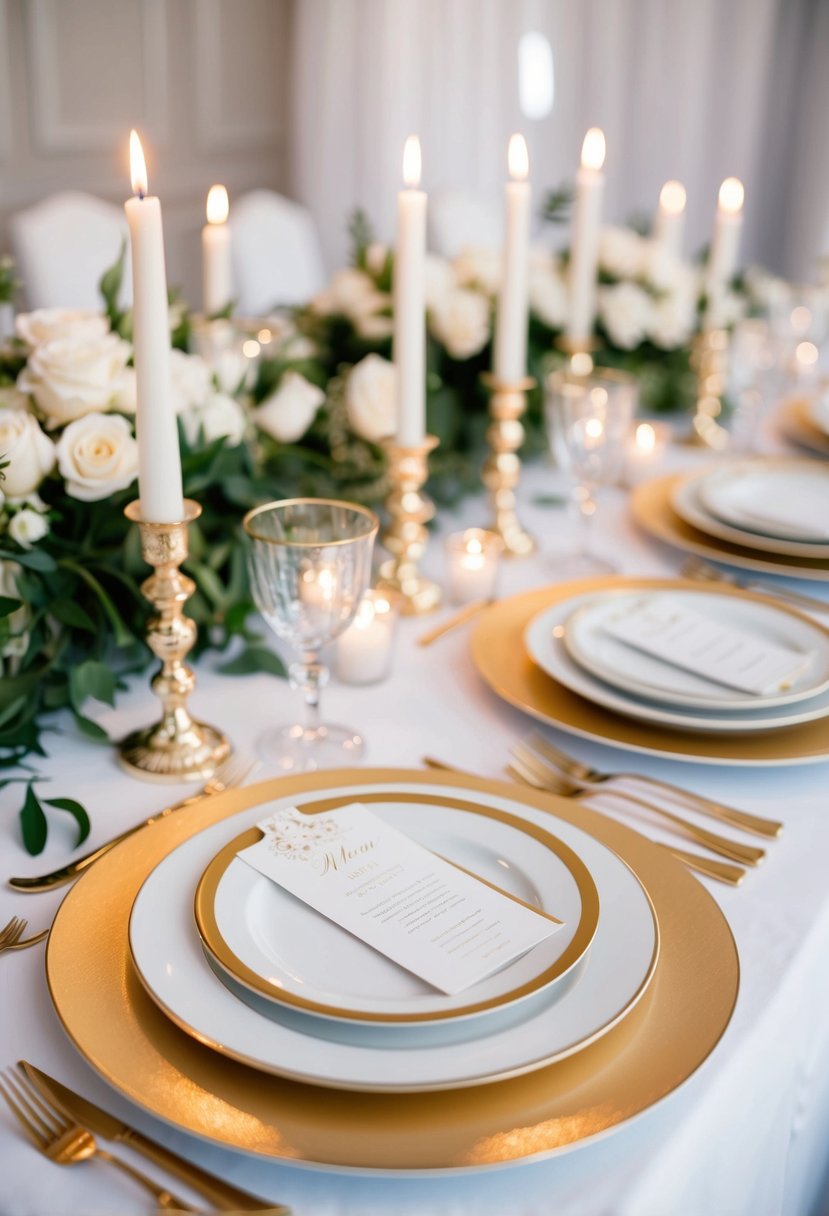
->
xmin=602 ymin=599 xmax=813 ymax=696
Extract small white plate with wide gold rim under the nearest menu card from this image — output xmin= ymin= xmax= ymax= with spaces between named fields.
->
xmin=196 ymin=803 xmax=598 ymax=1040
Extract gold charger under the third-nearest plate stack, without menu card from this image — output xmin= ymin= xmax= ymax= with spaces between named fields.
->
xmin=631 ymin=473 xmax=829 ymax=582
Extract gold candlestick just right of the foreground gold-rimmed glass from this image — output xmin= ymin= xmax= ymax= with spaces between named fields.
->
xmin=378 ymin=435 xmax=440 ymax=617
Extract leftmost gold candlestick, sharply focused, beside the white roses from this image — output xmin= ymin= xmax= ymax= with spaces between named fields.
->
xmin=118 ymin=499 xmax=231 ymax=782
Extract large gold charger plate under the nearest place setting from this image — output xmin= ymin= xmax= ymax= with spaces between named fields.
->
xmin=46 ymin=769 xmax=739 ymax=1171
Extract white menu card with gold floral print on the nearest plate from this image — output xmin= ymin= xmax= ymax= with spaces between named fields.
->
xmin=238 ymin=804 xmax=562 ymax=995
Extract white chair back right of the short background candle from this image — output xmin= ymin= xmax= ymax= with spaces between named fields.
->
xmin=230 ymin=190 xmax=325 ymax=316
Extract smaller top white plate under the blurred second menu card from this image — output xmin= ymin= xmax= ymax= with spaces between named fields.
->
xmin=563 ymin=589 xmax=829 ymax=710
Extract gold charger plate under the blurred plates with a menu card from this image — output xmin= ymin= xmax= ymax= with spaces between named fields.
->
xmin=472 ymin=575 xmax=829 ymax=766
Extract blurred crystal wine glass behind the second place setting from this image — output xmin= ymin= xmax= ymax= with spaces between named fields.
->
xmin=546 ymin=368 xmax=638 ymax=576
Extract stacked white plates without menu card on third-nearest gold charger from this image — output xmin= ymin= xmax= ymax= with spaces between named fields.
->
xmin=671 ymin=457 xmax=829 ymax=558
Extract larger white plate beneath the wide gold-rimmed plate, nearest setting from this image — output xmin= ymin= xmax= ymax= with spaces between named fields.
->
xmin=130 ymin=784 xmax=659 ymax=1092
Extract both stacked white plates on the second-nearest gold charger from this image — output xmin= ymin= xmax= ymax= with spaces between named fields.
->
xmin=525 ymin=586 xmax=829 ymax=733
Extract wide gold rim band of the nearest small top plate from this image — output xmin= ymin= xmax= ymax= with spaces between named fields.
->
xmin=194 ymin=794 xmax=599 ymax=1025
